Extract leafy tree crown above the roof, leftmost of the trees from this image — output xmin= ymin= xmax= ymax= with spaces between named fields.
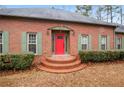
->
xmin=76 ymin=5 xmax=92 ymax=16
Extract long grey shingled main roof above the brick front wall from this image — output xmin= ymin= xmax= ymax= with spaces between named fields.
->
xmin=0 ymin=8 xmax=116 ymax=26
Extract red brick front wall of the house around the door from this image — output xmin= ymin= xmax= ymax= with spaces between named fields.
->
xmin=0 ymin=17 xmax=115 ymax=64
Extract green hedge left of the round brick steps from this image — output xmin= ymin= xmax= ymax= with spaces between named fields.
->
xmin=0 ymin=53 xmax=34 ymax=70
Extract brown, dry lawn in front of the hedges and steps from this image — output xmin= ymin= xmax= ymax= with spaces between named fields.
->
xmin=0 ymin=62 xmax=124 ymax=87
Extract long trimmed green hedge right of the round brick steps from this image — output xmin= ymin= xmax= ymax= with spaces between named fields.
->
xmin=79 ymin=50 xmax=124 ymax=63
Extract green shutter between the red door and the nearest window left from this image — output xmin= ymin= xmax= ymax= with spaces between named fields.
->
xmin=37 ymin=32 xmax=42 ymax=55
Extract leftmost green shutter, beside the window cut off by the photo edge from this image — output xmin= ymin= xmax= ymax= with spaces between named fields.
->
xmin=2 ymin=32 xmax=9 ymax=53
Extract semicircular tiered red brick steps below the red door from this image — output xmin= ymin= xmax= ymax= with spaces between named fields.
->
xmin=37 ymin=56 xmax=86 ymax=73
